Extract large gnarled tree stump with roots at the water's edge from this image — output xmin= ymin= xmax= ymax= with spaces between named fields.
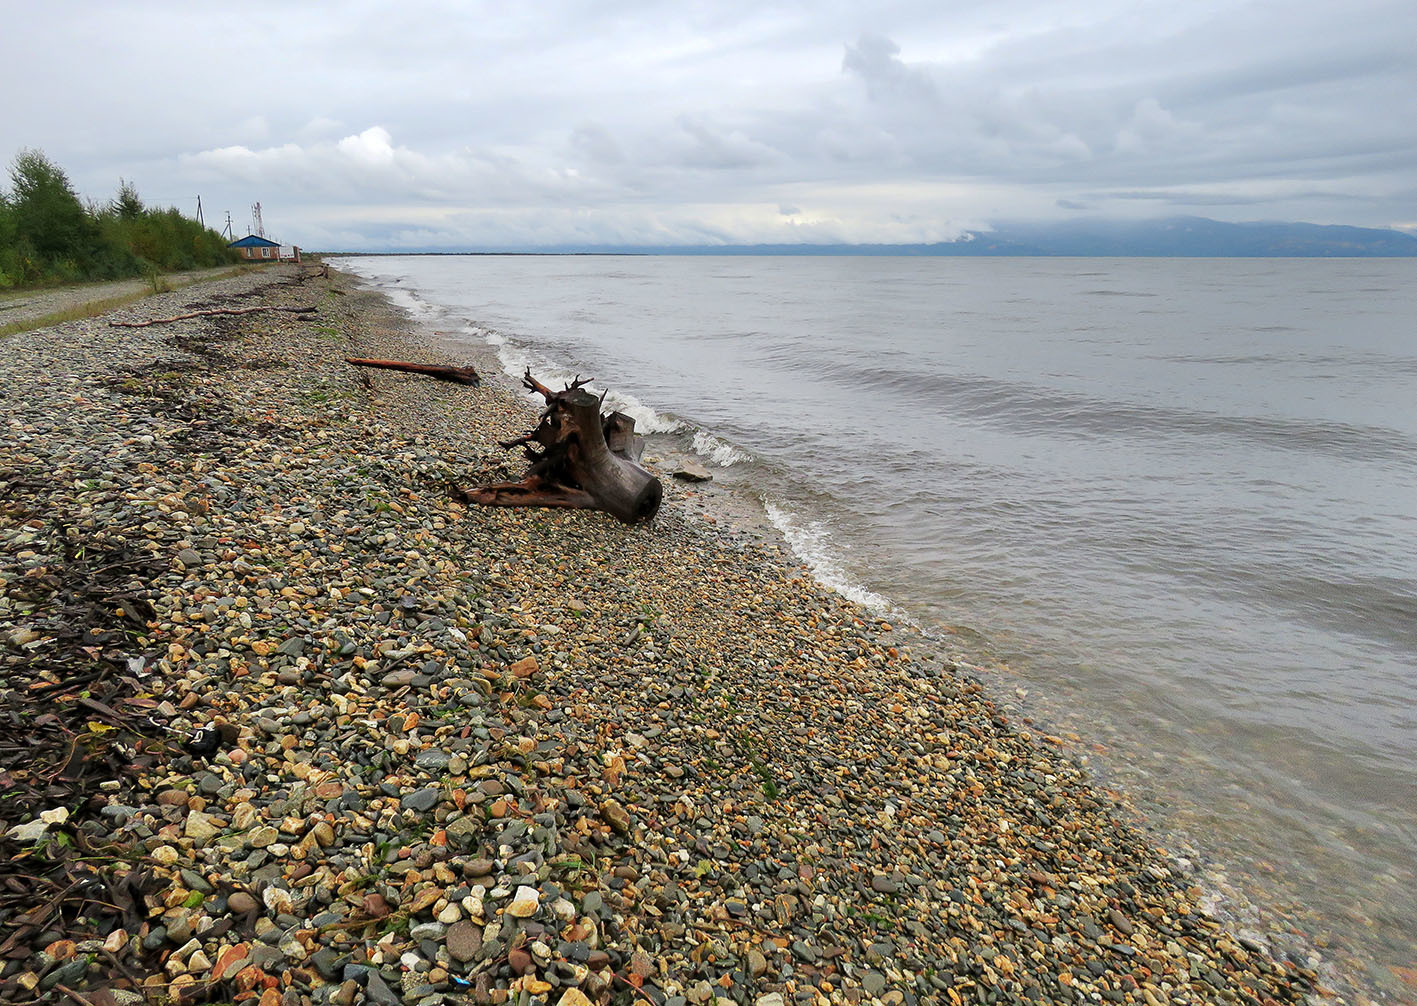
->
xmin=459 ymin=368 xmax=663 ymax=524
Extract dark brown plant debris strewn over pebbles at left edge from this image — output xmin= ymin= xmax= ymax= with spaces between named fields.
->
xmin=0 ymin=472 xmax=169 ymax=996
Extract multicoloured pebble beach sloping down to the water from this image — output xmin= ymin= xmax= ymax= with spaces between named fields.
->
xmin=0 ymin=266 xmax=1323 ymax=1006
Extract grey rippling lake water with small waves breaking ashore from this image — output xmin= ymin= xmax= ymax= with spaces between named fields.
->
xmin=340 ymin=256 xmax=1417 ymax=1000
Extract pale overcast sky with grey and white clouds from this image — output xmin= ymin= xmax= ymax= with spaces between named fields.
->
xmin=0 ymin=0 xmax=1417 ymax=251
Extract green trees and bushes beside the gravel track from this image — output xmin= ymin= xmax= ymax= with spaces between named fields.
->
xmin=0 ymin=150 xmax=239 ymax=289
